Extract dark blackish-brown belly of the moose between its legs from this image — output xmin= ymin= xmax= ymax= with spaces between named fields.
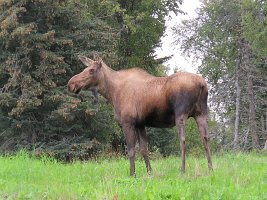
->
xmin=145 ymin=109 xmax=175 ymax=128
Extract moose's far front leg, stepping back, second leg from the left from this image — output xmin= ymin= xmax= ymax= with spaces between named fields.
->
xmin=138 ymin=127 xmax=152 ymax=174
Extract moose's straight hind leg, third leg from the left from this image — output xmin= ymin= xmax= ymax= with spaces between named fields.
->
xmin=175 ymin=115 xmax=186 ymax=172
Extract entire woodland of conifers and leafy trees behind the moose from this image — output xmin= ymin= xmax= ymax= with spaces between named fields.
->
xmin=0 ymin=0 xmax=267 ymax=159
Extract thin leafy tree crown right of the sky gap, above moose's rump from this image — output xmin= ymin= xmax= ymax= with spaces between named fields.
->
xmin=174 ymin=1 xmax=240 ymax=85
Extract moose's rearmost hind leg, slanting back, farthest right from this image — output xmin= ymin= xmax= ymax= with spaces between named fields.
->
xmin=195 ymin=115 xmax=212 ymax=170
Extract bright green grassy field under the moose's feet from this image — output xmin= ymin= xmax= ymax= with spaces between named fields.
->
xmin=0 ymin=153 xmax=267 ymax=200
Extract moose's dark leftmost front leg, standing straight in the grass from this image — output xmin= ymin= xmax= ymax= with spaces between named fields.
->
xmin=122 ymin=124 xmax=137 ymax=176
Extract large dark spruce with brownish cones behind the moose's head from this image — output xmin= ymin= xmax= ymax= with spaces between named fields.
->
xmin=0 ymin=0 xmax=119 ymax=152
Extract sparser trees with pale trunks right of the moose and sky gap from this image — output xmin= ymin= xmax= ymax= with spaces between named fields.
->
xmin=174 ymin=0 xmax=267 ymax=150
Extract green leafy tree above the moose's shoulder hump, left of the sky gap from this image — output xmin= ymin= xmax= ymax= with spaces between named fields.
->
xmin=116 ymin=0 xmax=182 ymax=74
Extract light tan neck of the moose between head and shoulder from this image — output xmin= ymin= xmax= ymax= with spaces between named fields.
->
xmin=97 ymin=63 xmax=119 ymax=103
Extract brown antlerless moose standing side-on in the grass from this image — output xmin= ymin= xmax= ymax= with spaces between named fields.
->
xmin=68 ymin=56 xmax=212 ymax=176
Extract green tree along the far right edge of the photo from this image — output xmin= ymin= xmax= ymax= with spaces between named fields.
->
xmin=242 ymin=0 xmax=267 ymax=150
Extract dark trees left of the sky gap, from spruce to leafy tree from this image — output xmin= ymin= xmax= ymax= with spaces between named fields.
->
xmin=0 ymin=0 xmax=191 ymax=159
